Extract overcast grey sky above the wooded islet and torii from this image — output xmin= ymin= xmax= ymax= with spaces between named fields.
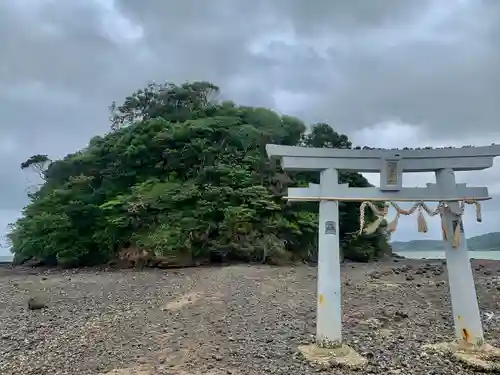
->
xmin=0 ymin=0 xmax=500 ymax=256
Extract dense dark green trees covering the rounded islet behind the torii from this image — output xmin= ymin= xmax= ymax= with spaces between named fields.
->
xmin=8 ymin=82 xmax=390 ymax=266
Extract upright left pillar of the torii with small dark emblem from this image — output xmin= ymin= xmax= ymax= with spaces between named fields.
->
xmin=316 ymin=169 xmax=342 ymax=348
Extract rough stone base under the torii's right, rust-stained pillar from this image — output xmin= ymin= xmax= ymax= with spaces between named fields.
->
xmin=424 ymin=342 xmax=500 ymax=373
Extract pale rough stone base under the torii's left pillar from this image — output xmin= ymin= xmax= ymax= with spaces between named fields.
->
xmin=299 ymin=344 xmax=367 ymax=370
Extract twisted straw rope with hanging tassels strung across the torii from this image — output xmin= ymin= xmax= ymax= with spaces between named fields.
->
xmin=359 ymin=200 xmax=482 ymax=248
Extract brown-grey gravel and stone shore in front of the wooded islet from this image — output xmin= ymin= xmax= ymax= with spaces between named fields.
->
xmin=0 ymin=260 xmax=500 ymax=375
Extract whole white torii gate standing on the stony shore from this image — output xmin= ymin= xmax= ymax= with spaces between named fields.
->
xmin=266 ymin=144 xmax=500 ymax=365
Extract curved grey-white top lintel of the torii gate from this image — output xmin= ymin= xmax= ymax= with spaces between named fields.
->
xmin=266 ymin=144 xmax=500 ymax=173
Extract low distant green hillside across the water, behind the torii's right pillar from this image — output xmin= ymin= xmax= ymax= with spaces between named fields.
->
xmin=391 ymin=232 xmax=500 ymax=252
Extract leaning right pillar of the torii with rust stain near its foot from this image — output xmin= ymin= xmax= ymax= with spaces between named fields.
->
xmin=436 ymin=169 xmax=484 ymax=346
